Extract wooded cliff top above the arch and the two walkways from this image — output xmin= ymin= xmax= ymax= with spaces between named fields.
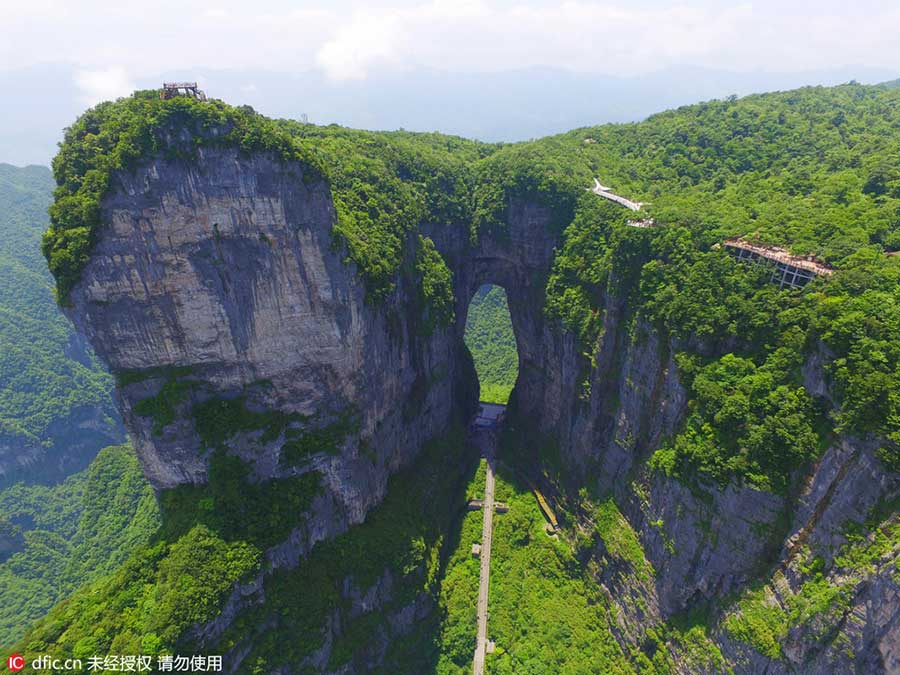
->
xmin=44 ymin=85 xmax=900 ymax=300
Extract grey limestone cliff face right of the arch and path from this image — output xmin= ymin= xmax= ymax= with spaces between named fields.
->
xmin=516 ymin=280 xmax=900 ymax=673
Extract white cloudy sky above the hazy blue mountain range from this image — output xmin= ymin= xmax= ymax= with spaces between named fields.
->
xmin=0 ymin=0 xmax=900 ymax=103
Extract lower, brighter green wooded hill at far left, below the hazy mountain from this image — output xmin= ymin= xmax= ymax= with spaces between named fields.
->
xmin=0 ymin=446 xmax=159 ymax=645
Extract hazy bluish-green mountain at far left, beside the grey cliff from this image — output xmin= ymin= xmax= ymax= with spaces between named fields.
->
xmin=0 ymin=164 xmax=124 ymax=487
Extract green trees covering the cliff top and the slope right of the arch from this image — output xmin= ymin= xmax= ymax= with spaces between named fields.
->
xmin=44 ymin=84 xmax=900 ymax=491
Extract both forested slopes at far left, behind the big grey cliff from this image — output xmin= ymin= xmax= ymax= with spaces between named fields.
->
xmin=0 ymin=164 xmax=149 ymax=645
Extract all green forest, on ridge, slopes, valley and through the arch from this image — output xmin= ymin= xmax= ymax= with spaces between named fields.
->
xmin=10 ymin=84 xmax=900 ymax=675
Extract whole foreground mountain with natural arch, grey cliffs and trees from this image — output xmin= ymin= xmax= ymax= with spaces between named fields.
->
xmin=8 ymin=84 xmax=900 ymax=674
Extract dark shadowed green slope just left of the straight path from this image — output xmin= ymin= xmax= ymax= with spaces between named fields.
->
xmin=218 ymin=430 xmax=472 ymax=673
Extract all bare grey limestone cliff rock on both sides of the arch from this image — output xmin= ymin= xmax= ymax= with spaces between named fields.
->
xmin=68 ymin=149 xmax=900 ymax=672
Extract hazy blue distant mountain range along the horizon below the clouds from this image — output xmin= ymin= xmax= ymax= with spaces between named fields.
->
xmin=0 ymin=66 xmax=898 ymax=165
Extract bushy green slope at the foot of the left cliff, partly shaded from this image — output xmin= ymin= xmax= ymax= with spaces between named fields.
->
xmin=10 ymin=450 xmax=320 ymax=658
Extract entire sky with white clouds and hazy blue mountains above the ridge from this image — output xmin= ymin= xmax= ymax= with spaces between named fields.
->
xmin=0 ymin=0 xmax=900 ymax=164
